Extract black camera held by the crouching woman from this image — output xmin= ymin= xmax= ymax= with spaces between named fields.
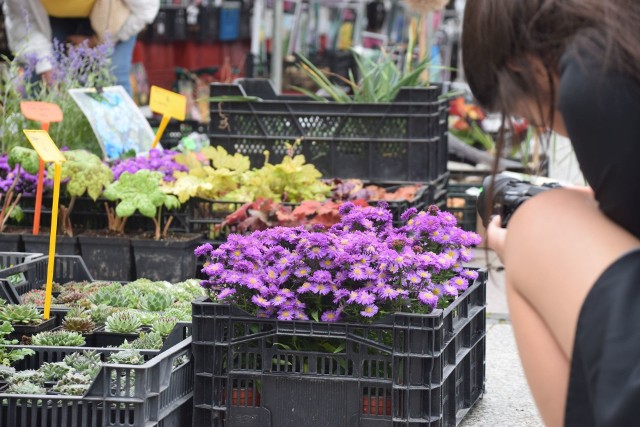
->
xmin=477 ymin=174 xmax=561 ymax=228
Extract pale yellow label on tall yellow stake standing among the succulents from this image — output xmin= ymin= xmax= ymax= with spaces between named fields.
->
xmin=23 ymin=130 xmax=66 ymax=319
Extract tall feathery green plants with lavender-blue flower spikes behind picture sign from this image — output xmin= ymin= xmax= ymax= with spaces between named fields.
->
xmin=0 ymin=39 xmax=115 ymax=155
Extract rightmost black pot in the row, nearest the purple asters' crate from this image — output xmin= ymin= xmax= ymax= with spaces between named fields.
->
xmin=131 ymin=234 xmax=202 ymax=283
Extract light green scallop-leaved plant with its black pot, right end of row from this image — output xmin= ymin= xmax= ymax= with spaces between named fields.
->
xmin=104 ymin=169 xmax=201 ymax=282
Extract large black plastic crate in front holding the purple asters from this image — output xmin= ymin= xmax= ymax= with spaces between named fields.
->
xmin=193 ymin=271 xmax=486 ymax=427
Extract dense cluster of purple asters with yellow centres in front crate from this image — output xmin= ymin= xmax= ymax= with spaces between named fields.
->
xmin=195 ymin=203 xmax=480 ymax=322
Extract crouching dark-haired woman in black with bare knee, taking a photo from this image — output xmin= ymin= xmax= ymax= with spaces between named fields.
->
xmin=462 ymin=0 xmax=640 ymax=427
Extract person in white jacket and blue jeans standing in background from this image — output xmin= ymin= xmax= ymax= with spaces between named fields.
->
xmin=3 ymin=0 xmax=160 ymax=94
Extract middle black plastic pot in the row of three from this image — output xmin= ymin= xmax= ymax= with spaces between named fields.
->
xmin=78 ymin=235 xmax=134 ymax=281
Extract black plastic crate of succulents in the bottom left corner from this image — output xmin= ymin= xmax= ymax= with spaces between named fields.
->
xmin=0 ymin=337 xmax=194 ymax=427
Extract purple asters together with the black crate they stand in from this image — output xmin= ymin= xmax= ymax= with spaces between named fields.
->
xmin=193 ymin=203 xmax=486 ymax=425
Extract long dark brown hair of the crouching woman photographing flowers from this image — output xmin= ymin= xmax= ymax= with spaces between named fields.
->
xmin=462 ymin=0 xmax=640 ymax=117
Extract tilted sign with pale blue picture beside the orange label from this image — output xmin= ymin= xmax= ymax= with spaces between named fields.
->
xmin=69 ymin=86 xmax=154 ymax=159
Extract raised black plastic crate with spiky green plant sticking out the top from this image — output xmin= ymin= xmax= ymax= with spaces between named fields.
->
xmin=209 ymin=79 xmax=448 ymax=182
